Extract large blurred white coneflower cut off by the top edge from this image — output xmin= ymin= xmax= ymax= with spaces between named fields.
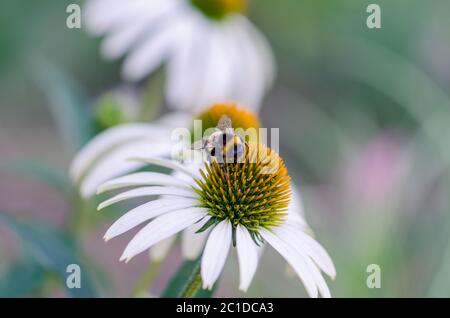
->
xmin=85 ymin=0 xmax=274 ymax=109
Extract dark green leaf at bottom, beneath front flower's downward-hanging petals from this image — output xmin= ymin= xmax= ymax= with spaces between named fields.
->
xmin=161 ymin=257 xmax=217 ymax=298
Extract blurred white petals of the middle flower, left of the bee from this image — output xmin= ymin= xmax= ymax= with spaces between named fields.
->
xmin=69 ymin=112 xmax=192 ymax=197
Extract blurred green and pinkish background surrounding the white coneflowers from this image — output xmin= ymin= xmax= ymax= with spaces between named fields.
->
xmin=0 ymin=0 xmax=450 ymax=297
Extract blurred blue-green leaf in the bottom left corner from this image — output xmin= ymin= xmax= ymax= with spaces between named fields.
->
xmin=0 ymin=215 xmax=99 ymax=297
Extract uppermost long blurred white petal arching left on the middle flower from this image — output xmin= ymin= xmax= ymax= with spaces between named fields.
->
xmin=69 ymin=124 xmax=170 ymax=182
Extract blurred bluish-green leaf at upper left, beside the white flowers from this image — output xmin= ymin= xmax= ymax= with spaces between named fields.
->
xmin=33 ymin=60 xmax=95 ymax=152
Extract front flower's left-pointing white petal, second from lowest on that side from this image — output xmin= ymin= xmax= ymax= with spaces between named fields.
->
xmin=104 ymin=198 xmax=198 ymax=241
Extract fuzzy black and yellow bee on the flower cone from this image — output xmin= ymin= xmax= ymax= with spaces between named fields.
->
xmin=192 ymin=115 xmax=247 ymax=169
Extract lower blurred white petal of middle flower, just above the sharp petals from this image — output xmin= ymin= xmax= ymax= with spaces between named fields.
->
xmin=80 ymin=140 xmax=172 ymax=197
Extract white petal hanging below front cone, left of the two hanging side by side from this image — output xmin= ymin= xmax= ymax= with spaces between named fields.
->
xmin=200 ymin=221 xmax=231 ymax=289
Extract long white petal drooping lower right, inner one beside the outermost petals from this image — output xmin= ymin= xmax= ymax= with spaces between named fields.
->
xmin=259 ymin=229 xmax=318 ymax=298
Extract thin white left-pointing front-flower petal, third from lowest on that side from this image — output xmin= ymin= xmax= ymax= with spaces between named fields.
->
xmin=97 ymin=187 xmax=196 ymax=210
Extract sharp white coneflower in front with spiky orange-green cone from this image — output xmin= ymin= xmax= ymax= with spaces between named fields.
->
xmin=99 ymin=143 xmax=335 ymax=297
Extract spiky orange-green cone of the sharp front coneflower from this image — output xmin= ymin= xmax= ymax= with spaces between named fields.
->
xmin=195 ymin=144 xmax=290 ymax=238
